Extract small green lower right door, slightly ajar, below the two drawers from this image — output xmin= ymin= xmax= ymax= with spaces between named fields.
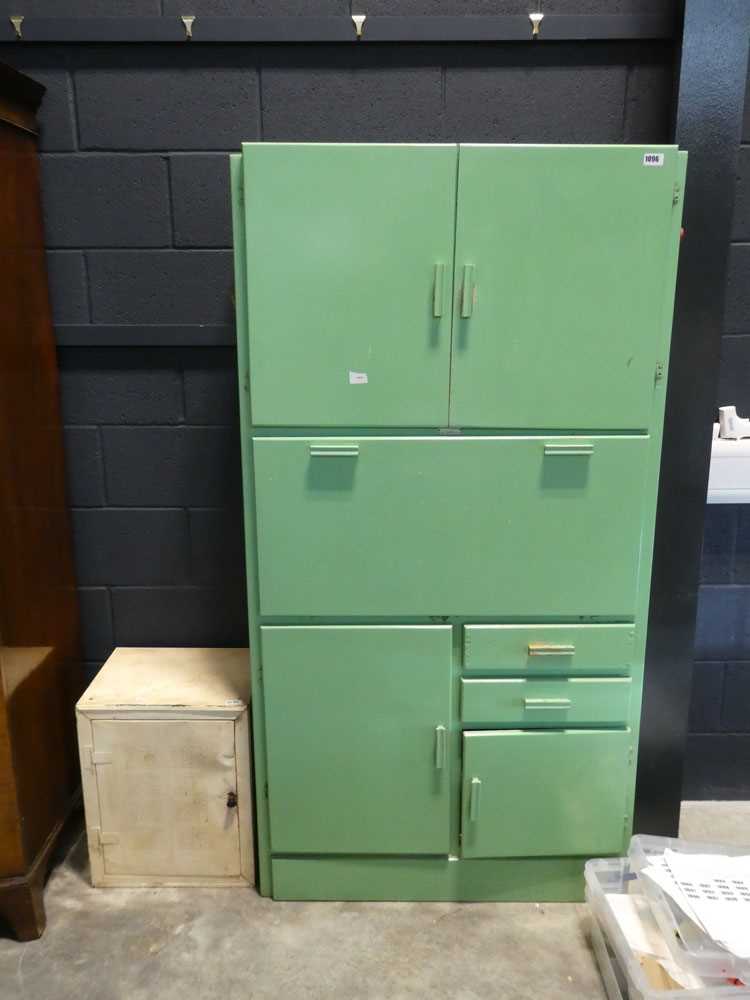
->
xmin=461 ymin=729 xmax=633 ymax=858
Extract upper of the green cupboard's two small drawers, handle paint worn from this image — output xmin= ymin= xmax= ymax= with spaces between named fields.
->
xmin=464 ymin=625 xmax=635 ymax=675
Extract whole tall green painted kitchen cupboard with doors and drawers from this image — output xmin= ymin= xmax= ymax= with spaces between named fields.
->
xmin=230 ymin=143 xmax=687 ymax=900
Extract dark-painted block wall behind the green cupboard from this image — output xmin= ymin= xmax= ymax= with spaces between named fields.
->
xmin=0 ymin=0 xmax=750 ymax=796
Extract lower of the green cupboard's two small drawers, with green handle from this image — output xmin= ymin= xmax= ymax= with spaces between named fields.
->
xmin=461 ymin=677 xmax=630 ymax=729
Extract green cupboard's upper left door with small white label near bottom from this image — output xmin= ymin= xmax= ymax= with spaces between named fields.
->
xmin=243 ymin=143 xmax=458 ymax=427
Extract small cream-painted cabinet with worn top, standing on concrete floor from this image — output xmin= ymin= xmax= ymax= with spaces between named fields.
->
xmin=76 ymin=647 xmax=254 ymax=886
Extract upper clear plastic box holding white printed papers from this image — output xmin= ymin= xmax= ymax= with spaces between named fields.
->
xmin=629 ymin=835 xmax=750 ymax=982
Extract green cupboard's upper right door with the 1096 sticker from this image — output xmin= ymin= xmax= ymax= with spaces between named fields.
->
xmin=450 ymin=145 xmax=681 ymax=430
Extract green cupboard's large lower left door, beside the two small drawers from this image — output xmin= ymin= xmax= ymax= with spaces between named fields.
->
xmin=261 ymin=625 xmax=451 ymax=855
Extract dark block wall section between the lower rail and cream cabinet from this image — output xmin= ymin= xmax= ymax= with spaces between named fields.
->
xmin=59 ymin=347 xmax=246 ymax=669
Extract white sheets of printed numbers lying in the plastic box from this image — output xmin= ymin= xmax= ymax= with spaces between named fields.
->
xmin=639 ymin=848 xmax=750 ymax=959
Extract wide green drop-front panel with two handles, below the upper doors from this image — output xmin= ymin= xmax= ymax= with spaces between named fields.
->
xmin=253 ymin=435 xmax=649 ymax=621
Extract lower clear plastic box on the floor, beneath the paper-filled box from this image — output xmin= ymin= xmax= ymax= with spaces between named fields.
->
xmin=585 ymin=858 xmax=750 ymax=1000
